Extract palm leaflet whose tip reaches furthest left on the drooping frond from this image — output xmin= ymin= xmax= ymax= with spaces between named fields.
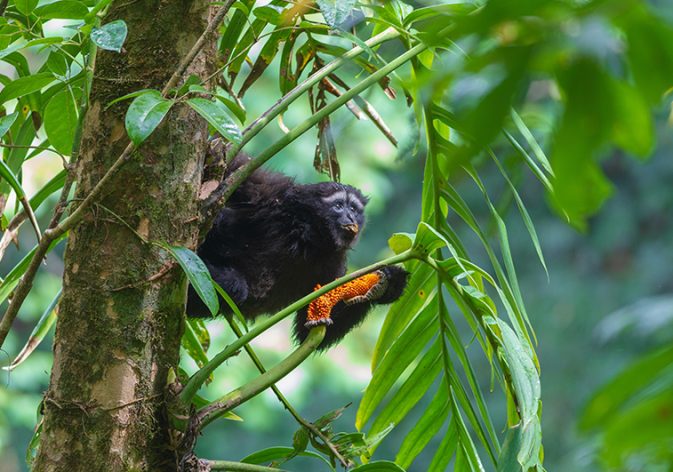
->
xmin=355 ymin=299 xmax=438 ymax=430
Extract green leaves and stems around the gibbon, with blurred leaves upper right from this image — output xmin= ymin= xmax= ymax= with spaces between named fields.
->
xmin=0 ymin=0 xmax=673 ymax=471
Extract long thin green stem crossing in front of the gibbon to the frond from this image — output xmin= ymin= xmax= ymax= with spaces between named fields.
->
xmin=180 ymin=250 xmax=416 ymax=405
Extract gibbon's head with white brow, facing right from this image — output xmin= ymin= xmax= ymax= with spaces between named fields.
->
xmin=314 ymin=182 xmax=369 ymax=249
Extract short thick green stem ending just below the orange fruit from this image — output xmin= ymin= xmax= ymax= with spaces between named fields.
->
xmin=197 ymin=326 xmax=327 ymax=430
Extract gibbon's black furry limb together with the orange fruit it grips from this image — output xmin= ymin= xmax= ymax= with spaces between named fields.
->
xmin=294 ymin=266 xmax=409 ymax=350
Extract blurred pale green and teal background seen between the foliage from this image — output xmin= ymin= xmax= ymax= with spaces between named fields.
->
xmin=0 ymin=2 xmax=673 ymax=472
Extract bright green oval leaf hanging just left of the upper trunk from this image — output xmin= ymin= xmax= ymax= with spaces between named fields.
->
xmin=44 ymin=88 xmax=79 ymax=156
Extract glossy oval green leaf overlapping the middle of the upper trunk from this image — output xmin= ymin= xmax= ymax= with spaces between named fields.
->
xmin=126 ymin=90 xmax=174 ymax=146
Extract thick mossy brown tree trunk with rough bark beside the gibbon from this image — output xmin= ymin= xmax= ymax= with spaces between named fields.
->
xmin=34 ymin=0 xmax=212 ymax=472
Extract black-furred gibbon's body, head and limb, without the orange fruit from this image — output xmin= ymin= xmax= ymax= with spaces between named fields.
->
xmin=187 ymin=155 xmax=408 ymax=349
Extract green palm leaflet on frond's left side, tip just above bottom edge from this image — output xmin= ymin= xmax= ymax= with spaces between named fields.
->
xmin=395 ymin=383 xmax=451 ymax=469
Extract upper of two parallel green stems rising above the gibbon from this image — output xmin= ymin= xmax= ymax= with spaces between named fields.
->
xmin=227 ymin=28 xmax=400 ymax=157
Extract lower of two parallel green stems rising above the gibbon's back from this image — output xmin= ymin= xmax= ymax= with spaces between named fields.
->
xmin=220 ymin=39 xmax=428 ymax=201
